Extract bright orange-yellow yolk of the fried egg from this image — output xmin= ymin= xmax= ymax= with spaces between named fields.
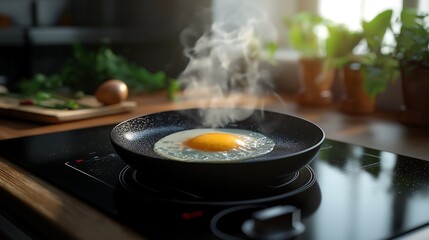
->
xmin=185 ymin=133 xmax=244 ymax=152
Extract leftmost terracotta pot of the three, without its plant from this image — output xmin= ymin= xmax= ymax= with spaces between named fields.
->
xmin=297 ymin=59 xmax=334 ymax=107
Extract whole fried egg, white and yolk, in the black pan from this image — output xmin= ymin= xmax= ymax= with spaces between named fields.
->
xmin=154 ymin=128 xmax=275 ymax=162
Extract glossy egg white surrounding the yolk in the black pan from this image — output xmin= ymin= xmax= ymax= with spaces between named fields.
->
xmin=154 ymin=128 xmax=275 ymax=162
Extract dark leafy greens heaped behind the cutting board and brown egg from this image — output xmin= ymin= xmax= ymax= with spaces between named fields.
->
xmin=19 ymin=44 xmax=177 ymax=95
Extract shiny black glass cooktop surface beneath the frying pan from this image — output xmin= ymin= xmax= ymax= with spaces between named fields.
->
xmin=0 ymin=125 xmax=429 ymax=240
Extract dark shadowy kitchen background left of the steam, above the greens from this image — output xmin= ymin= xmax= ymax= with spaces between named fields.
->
xmin=0 ymin=0 xmax=211 ymax=92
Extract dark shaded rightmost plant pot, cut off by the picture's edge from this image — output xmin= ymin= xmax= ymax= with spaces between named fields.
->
xmin=401 ymin=64 xmax=429 ymax=126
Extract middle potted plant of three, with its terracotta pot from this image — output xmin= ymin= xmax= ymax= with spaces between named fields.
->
xmin=334 ymin=10 xmax=399 ymax=114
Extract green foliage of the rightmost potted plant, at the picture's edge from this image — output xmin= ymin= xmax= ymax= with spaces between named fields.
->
xmin=394 ymin=9 xmax=429 ymax=70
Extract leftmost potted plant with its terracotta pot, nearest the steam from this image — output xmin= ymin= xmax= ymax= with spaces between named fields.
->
xmin=285 ymin=12 xmax=334 ymax=106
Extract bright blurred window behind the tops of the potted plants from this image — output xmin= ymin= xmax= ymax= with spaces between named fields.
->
xmin=213 ymin=0 xmax=429 ymax=47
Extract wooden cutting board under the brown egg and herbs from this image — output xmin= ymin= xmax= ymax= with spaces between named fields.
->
xmin=0 ymin=95 xmax=137 ymax=123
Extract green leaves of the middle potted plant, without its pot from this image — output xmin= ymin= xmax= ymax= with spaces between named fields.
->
xmin=326 ymin=10 xmax=399 ymax=97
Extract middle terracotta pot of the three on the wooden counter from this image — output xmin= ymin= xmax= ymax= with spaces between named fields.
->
xmin=340 ymin=65 xmax=375 ymax=115
